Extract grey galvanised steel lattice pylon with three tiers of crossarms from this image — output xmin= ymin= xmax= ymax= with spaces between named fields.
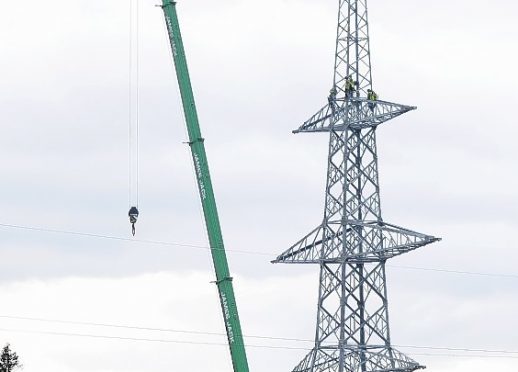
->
xmin=273 ymin=0 xmax=439 ymax=372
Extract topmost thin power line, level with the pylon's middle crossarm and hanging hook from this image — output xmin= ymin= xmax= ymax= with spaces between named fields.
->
xmin=0 ymin=223 xmax=518 ymax=279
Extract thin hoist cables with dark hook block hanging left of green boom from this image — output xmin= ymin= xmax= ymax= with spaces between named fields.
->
xmin=128 ymin=0 xmax=140 ymax=236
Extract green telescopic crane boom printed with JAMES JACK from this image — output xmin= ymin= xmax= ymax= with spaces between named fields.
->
xmin=162 ymin=0 xmax=252 ymax=372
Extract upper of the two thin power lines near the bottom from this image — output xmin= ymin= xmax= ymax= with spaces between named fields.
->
xmin=0 ymin=315 xmax=518 ymax=357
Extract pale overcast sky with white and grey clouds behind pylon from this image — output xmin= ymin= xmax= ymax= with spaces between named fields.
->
xmin=0 ymin=0 xmax=518 ymax=372
